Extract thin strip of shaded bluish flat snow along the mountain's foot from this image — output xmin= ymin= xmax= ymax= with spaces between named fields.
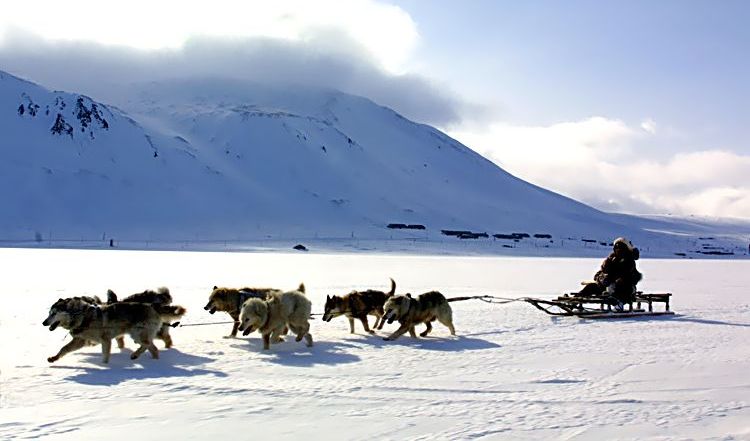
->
xmin=0 ymin=234 xmax=750 ymax=260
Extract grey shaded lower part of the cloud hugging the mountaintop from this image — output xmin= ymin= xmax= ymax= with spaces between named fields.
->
xmin=0 ymin=29 xmax=470 ymax=125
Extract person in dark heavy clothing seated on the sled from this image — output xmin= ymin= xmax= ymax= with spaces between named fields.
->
xmin=578 ymin=237 xmax=643 ymax=310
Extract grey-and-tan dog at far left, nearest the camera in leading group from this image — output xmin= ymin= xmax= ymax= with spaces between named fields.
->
xmin=42 ymin=297 xmax=185 ymax=363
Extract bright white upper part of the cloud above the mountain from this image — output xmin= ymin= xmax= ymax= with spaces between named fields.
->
xmin=0 ymin=0 xmax=419 ymax=73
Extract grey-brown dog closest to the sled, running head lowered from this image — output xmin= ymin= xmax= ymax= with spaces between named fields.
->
xmin=383 ymin=291 xmax=456 ymax=340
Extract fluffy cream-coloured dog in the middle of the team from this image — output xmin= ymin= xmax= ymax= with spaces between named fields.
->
xmin=239 ymin=284 xmax=313 ymax=349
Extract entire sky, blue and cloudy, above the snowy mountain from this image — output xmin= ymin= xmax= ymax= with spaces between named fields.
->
xmin=0 ymin=0 xmax=750 ymax=218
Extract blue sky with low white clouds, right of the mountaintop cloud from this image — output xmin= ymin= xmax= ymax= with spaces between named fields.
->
xmin=392 ymin=0 xmax=750 ymax=217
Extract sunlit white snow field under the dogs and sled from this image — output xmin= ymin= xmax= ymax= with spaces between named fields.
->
xmin=0 ymin=249 xmax=750 ymax=440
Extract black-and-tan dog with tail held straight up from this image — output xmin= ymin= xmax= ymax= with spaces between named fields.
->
xmin=323 ymin=279 xmax=396 ymax=334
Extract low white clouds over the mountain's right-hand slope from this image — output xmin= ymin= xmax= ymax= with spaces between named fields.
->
xmin=451 ymin=117 xmax=750 ymax=218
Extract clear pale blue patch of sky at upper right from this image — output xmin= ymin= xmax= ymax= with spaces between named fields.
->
xmin=393 ymin=0 xmax=750 ymax=151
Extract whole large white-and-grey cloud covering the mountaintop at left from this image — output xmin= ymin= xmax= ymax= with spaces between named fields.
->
xmin=0 ymin=0 xmax=486 ymax=126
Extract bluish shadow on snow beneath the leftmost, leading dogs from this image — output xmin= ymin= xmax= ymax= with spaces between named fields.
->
xmin=50 ymin=348 xmax=227 ymax=386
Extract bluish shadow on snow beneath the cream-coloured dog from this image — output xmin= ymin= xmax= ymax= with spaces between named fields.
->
xmin=231 ymin=338 xmax=361 ymax=367
